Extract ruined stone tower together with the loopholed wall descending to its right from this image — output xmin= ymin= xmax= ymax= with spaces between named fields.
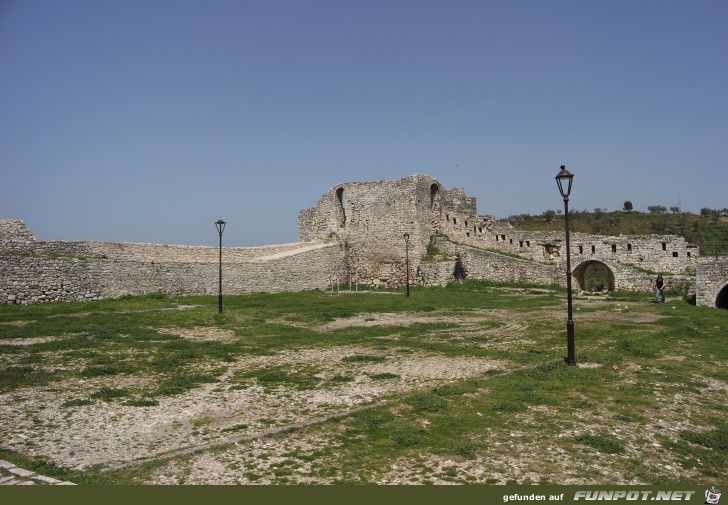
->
xmin=299 ymin=174 xmax=699 ymax=290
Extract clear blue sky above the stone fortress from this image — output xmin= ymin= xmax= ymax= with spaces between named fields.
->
xmin=0 ymin=0 xmax=728 ymax=246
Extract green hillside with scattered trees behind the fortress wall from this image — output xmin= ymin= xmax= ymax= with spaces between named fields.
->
xmin=503 ymin=206 xmax=728 ymax=256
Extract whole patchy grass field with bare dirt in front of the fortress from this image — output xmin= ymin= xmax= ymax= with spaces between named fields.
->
xmin=0 ymin=282 xmax=728 ymax=485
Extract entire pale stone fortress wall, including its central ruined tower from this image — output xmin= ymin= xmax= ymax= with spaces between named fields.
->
xmin=0 ymin=174 xmax=728 ymax=305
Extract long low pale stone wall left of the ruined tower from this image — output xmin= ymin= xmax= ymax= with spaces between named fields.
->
xmin=0 ymin=221 xmax=343 ymax=303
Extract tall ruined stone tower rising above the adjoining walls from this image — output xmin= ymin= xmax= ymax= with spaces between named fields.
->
xmin=298 ymin=174 xmax=494 ymax=286
